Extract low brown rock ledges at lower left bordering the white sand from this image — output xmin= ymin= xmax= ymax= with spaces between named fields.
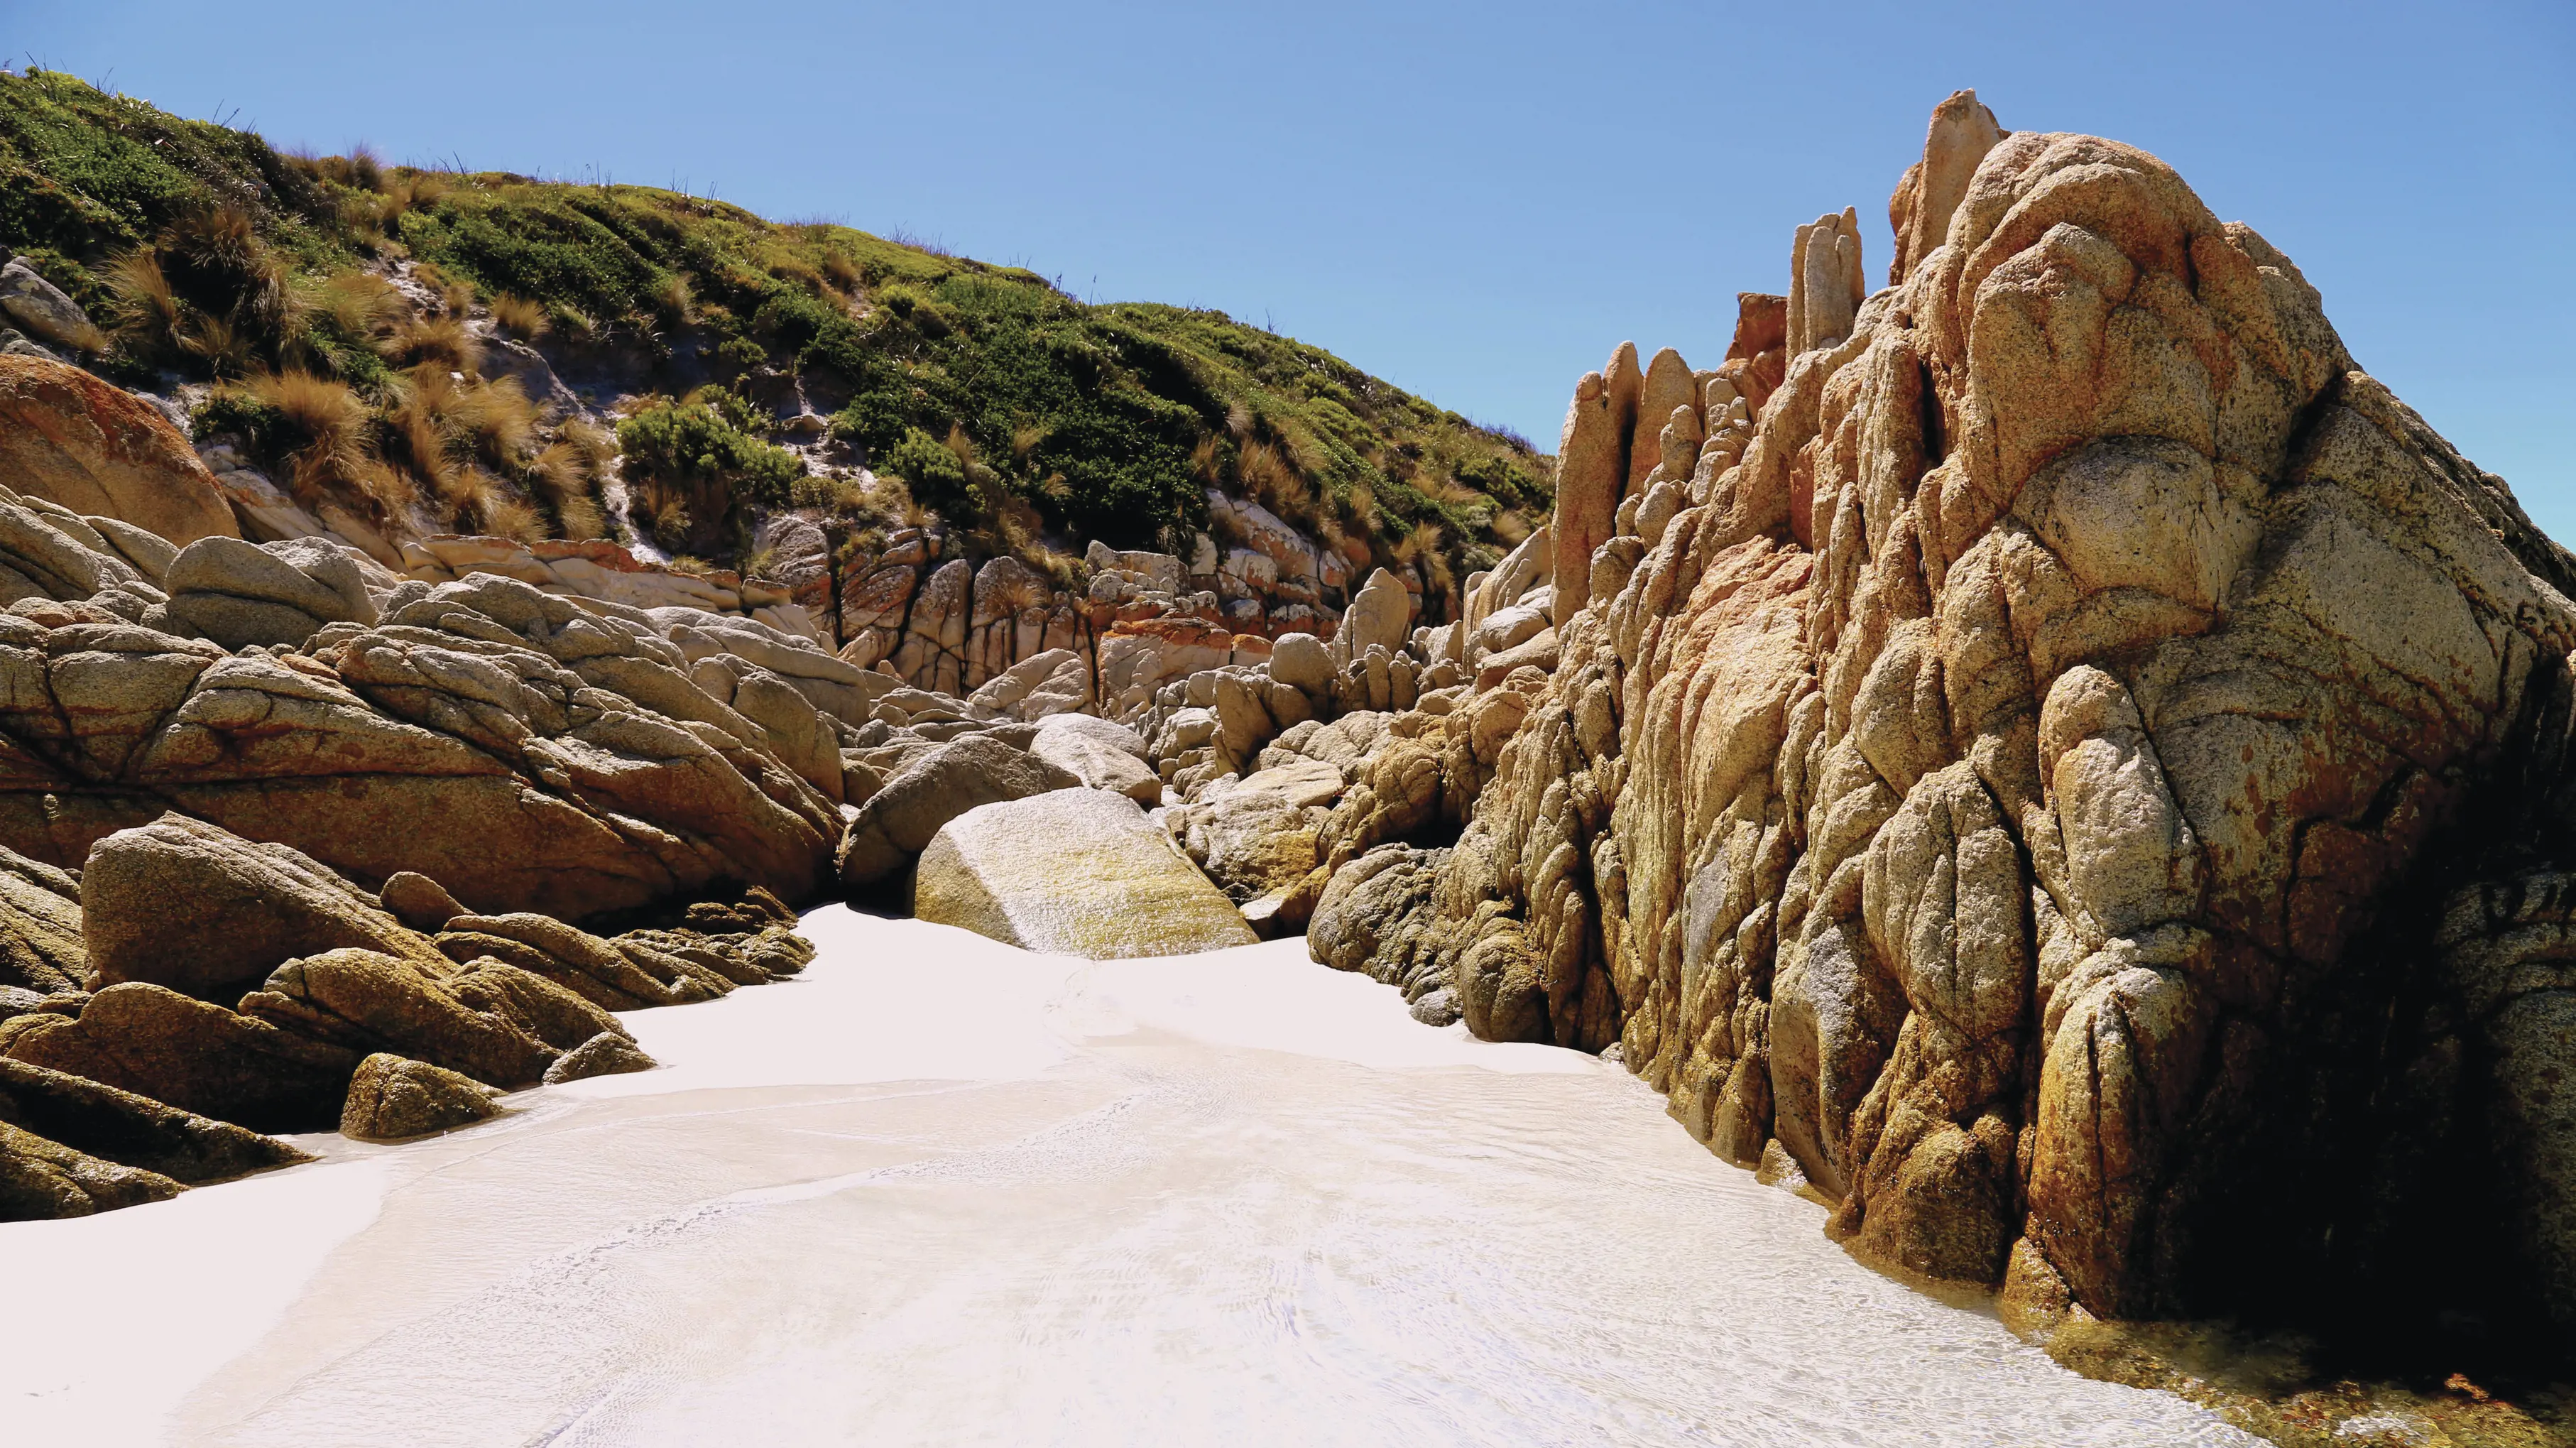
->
xmin=0 ymin=798 xmax=814 ymax=1149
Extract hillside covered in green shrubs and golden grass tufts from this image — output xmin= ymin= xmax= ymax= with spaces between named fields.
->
xmin=0 ymin=72 xmax=1551 ymax=587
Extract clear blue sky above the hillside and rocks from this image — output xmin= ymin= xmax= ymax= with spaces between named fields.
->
xmin=0 ymin=0 xmax=2576 ymax=541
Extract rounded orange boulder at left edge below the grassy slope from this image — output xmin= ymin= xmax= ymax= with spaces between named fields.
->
xmin=0 ymin=356 xmax=239 ymax=546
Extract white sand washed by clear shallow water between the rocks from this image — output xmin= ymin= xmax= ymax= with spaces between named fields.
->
xmin=0 ymin=907 xmax=2254 ymax=1448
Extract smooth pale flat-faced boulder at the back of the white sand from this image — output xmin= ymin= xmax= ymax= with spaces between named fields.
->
xmin=912 ymin=788 xmax=1252 ymax=961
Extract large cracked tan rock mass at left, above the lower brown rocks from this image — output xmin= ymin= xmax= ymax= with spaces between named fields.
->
xmin=0 ymin=535 xmax=858 ymax=918
